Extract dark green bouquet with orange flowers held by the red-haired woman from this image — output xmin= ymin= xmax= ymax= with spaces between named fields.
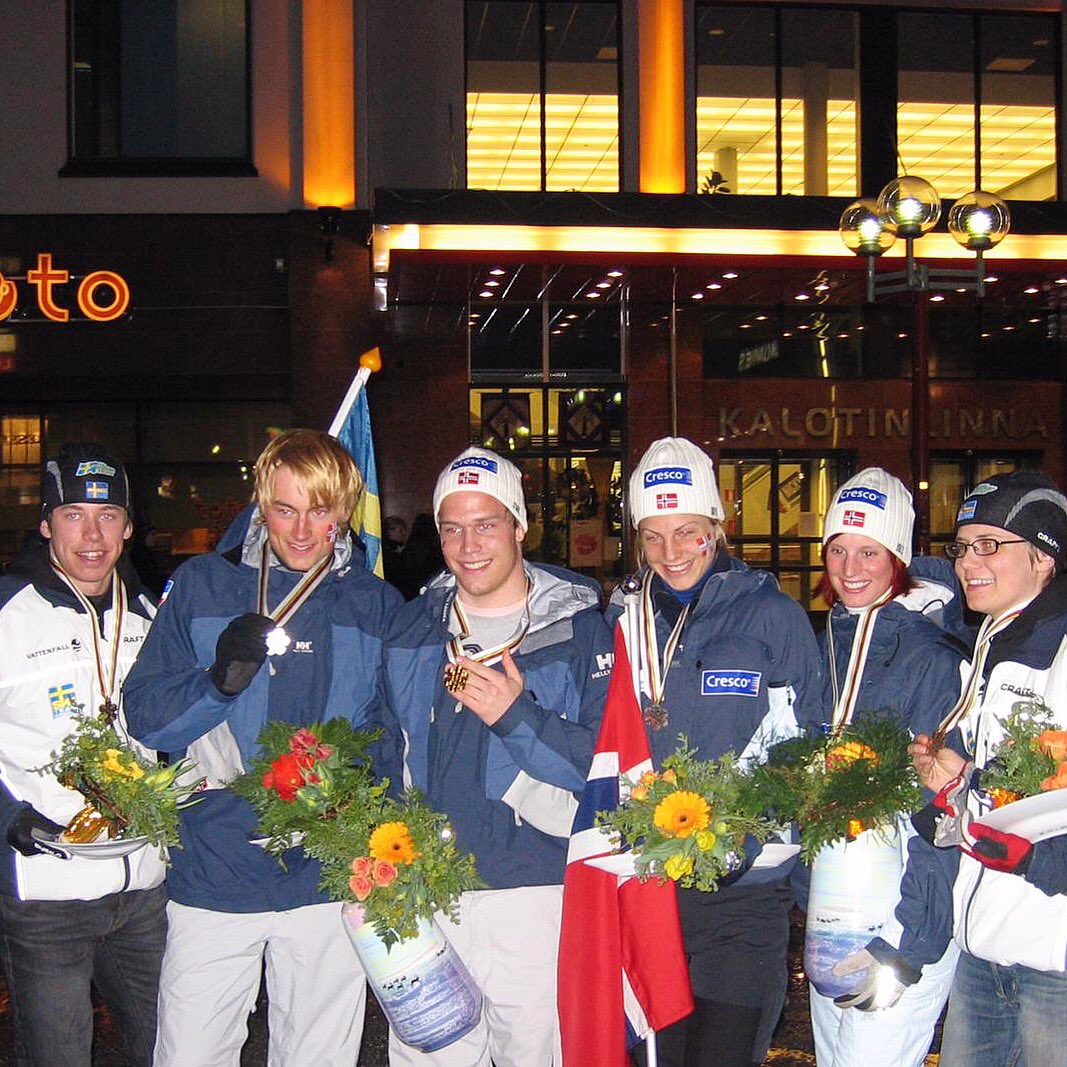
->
xmin=751 ymin=715 xmax=922 ymax=862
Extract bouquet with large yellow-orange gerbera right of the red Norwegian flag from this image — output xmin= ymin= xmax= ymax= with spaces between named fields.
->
xmin=596 ymin=736 xmax=775 ymax=892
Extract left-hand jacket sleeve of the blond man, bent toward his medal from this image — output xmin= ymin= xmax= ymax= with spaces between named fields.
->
xmin=123 ymin=564 xmax=237 ymax=752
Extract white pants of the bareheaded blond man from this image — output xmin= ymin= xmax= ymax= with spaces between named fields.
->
xmin=154 ymin=902 xmax=367 ymax=1067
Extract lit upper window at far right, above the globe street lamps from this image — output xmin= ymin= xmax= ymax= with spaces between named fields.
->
xmin=896 ymin=13 xmax=1058 ymax=200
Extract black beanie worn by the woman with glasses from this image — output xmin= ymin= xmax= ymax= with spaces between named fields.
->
xmin=956 ymin=471 xmax=1067 ymax=571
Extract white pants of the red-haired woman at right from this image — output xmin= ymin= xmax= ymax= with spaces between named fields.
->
xmin=809 ymin=942 xmax=959 ymax=1067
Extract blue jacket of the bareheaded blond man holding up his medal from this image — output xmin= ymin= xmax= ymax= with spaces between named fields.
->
xmin=125 ymin=513 xmax=400 ymax=912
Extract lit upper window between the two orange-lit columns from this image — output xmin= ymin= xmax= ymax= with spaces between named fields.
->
xmin=466 ymin=0 xmax=619 ymax=192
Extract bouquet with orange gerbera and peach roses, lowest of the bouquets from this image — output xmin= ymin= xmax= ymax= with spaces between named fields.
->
xmin=303 ymin=791 xmax=481 ymax=945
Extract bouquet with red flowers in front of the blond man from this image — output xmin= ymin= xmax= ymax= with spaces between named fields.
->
xmin=229 ymin=719 xmax=385 ymax=858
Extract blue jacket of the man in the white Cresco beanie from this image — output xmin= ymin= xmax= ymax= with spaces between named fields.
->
xmin=381 ymin=562 xmax=614 ymax=889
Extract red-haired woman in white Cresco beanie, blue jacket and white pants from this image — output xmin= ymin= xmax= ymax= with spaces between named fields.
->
xmin=811 ymin=467 xmax=962 ymax=1067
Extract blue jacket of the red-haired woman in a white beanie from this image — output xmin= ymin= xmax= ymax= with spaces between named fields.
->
xmin=815 ymin=582 xmax=965 ymax=969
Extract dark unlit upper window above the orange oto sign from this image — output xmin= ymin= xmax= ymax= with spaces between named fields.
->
xmin=61 ymin=0 xmax=255 ymax=176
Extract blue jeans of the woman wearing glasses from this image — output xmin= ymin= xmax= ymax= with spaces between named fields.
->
xmin=941 ymin=952 xmax=1067 ymax=1067
